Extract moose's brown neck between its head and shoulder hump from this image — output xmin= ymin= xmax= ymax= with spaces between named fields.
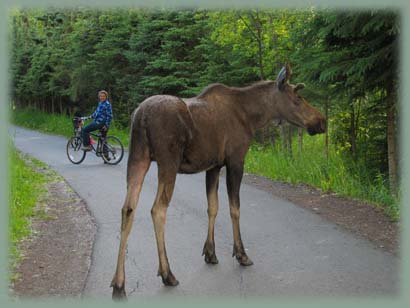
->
xmin=235 ymin=81 xmax=280 ymax=134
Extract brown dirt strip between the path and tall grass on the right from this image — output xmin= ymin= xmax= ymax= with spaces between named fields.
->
xmin=243 ymin=174 xmax=400 ymax=255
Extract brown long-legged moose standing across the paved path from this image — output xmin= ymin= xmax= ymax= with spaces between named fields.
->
xmin=111 ymin=64 xmax=326 ymax=299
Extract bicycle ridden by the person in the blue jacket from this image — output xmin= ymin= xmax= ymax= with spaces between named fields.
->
xmin=66 ymin=117 xmax=124 ymax=165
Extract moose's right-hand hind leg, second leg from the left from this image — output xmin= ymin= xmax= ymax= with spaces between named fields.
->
xmin=151 ymin=166 xmax=179 ymax=286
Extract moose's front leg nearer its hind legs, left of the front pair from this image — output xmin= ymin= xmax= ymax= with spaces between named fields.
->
xmin=202 ymin=167 xmax=220 ymax=264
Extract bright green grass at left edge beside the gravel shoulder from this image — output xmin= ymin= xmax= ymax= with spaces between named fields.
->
xmin=9 ymin=146 xmax=47 ymax=274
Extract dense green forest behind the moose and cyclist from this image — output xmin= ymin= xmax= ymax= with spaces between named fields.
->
xmin=9 ymin=8 xmax=400 ymax=214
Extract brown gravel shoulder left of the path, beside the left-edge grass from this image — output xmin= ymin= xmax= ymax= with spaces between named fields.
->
xmin=11 ymin=169 xmax=96 ymax=298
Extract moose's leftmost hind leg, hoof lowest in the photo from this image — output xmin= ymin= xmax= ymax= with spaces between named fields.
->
xmin=111 ymin=157 xmax=150 ymax=299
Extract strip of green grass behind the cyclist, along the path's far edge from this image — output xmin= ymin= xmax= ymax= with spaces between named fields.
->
xmin=11 ymin=108 xmax=129 ymax=148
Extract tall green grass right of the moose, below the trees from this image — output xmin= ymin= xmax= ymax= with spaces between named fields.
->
xmin=245 ymin=136 xmax=399 ymax=219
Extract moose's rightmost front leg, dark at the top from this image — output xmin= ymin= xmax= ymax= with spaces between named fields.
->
xmin=226 ymin=162 xmax=253 ymax=266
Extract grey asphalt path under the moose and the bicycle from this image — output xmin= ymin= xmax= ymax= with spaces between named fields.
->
xmin=10 ymin=128 xmax=400 ymax=299
